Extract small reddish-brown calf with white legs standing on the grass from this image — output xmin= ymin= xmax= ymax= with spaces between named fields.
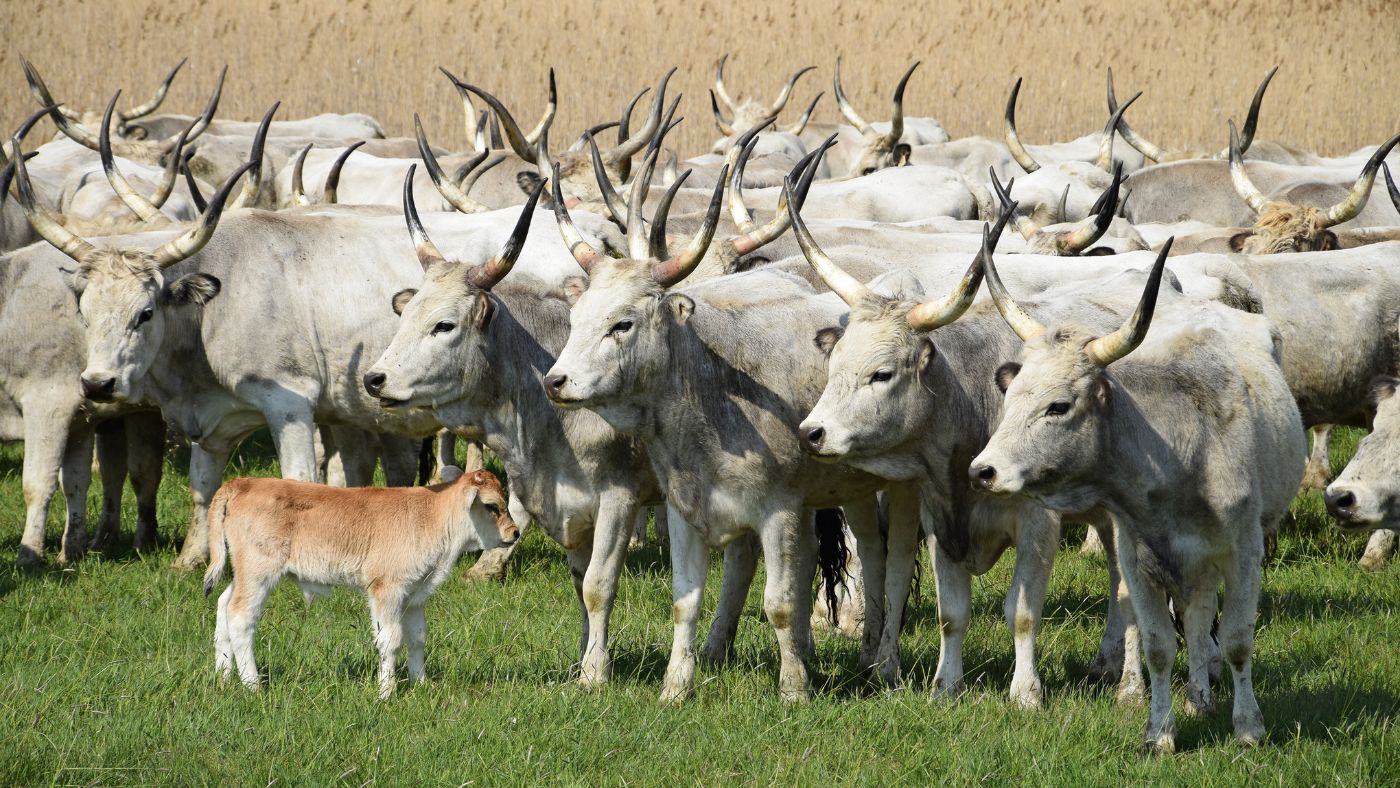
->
xmin=204 ymin=470 xmax=519 ymax=700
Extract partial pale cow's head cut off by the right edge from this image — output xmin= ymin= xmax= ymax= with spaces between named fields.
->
xmin=1324 ymin=375 xmax=1400 ymax=529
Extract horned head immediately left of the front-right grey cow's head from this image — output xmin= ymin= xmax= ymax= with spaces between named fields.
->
xmin=790 ymin=194 xmax=1011 ymax=479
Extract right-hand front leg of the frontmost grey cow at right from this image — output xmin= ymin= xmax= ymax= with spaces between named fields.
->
xmin=1219 ymin=519 xmax=1266 ymax=746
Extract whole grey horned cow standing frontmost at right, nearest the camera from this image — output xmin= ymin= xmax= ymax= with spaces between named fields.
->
xmin=967 ymin=240 xmax=1306 ymax=753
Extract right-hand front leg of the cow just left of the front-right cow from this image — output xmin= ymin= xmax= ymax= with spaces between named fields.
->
xmin=1002 ymin=507 xmax=1060 ymax=708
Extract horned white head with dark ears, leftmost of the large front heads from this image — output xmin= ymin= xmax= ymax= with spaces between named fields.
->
xmin=11 ymin=138 xmax=248 ymax=400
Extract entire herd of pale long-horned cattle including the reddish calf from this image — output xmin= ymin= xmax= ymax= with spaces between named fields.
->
xmin=0 ymin=52 xmax=1400 ymax=752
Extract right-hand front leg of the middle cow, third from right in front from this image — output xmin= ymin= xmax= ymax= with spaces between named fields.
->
xmin=759 ymin=509 xmax=816 ymax=703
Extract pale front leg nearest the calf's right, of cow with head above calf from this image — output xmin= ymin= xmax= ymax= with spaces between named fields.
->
xmin=578 ymin=495 xmax=632 ymax=687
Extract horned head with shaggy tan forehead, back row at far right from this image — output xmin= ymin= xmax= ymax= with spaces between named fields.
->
xmin=1229 ymin=122 xmax=1400 ymax=255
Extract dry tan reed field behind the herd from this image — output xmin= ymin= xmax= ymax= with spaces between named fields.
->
xmin=0 ymin=0 xmax=1400 ymax=154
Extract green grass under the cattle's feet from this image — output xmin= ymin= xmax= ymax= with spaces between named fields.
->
xmin=0 ymin=432 xmax=1400 ymax=785
